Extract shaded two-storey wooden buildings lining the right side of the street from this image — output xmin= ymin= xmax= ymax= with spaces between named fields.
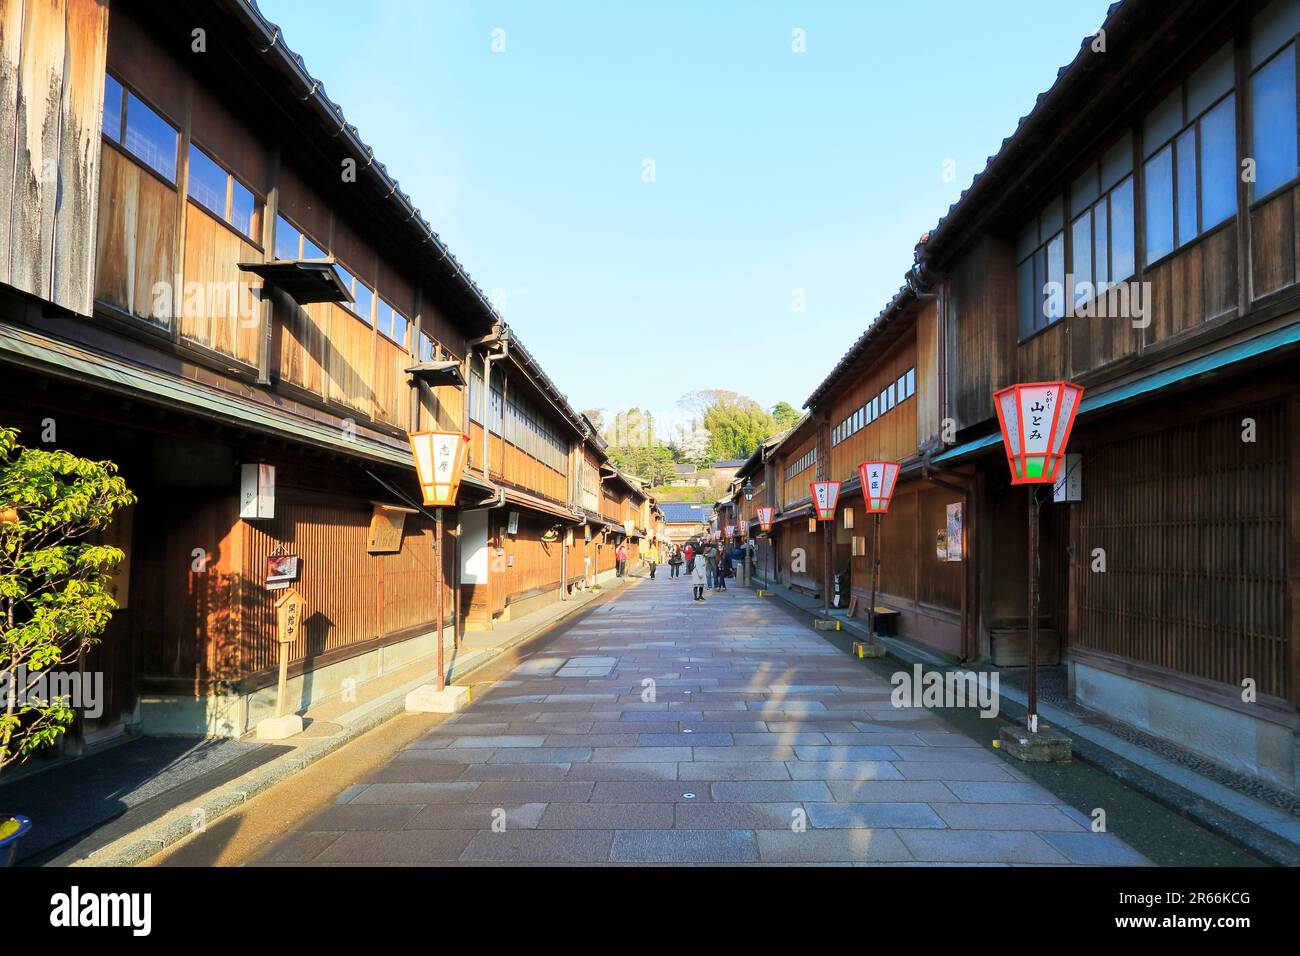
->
xmin=780 ymin=0 xmax=1300 ymax=788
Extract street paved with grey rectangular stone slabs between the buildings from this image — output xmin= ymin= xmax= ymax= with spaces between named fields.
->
xmin=261 ymin=578 xmax=1145 ymax=865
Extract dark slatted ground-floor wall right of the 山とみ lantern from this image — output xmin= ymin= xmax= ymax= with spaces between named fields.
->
xmin=1071 ymin=402 xmax=1296 ymax=698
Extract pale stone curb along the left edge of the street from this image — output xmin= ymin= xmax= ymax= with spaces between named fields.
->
xmin=70 ymin=579 xmax=629 ymax=866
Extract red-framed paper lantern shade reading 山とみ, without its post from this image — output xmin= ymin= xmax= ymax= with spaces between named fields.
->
xmin=993 ymin=381 xmax=1083 ymax=485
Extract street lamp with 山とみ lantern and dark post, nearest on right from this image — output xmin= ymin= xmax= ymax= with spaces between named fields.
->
xmin=993 ymin=381 xmax=1083 ymax=734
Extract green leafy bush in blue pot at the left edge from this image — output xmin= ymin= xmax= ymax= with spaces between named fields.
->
xmin=0 ymin=428 xmax=135 ymax=865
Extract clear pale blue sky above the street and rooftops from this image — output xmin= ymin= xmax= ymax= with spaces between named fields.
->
xmin=260 ymin=0 xmax=1108 ymax=439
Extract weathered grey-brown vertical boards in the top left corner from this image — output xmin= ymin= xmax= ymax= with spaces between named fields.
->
xmin=0 ymin=0 xmax=108 ymax=315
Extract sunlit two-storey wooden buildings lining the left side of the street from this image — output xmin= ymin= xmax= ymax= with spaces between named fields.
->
xmin=0 ymin=0 xmax=611 ymax=744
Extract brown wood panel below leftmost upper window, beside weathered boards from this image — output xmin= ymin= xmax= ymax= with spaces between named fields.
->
xmin=95 ymin=144 xmax=178 ymax=328
